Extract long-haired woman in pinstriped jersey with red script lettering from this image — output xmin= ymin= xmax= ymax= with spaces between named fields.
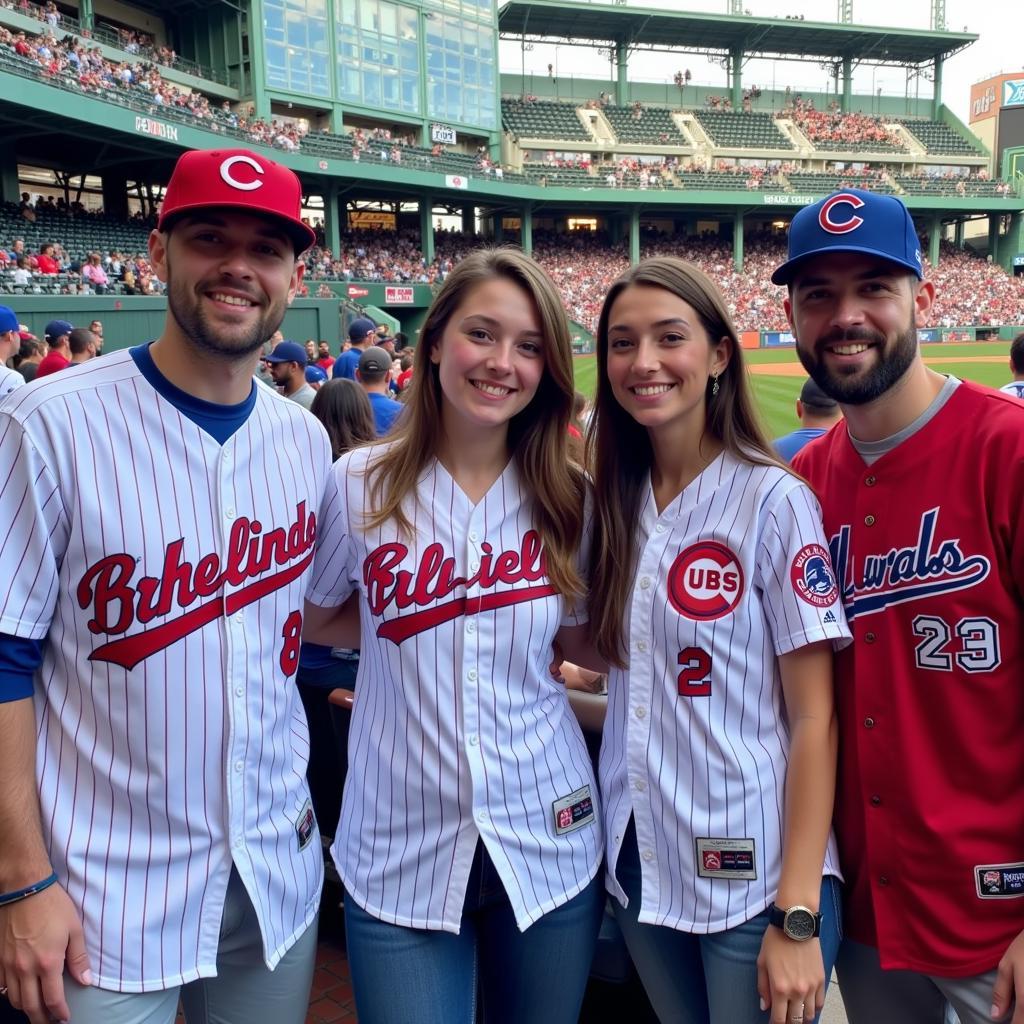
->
xmin=306 ymin=249 xmax=603 ymax=1024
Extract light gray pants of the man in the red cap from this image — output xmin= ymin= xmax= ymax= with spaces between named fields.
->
xmin=65 ymin=870 xmax=316 ymax=1024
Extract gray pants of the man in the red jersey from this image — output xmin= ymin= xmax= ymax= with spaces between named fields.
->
xmin=836 ymin=939 xmax=1013 ymax=1024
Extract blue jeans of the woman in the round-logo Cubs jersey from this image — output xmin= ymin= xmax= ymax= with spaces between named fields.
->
xmin=611 ymin=818 xmax=843 ymax=1024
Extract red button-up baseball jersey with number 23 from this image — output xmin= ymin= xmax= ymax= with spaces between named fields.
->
xmin=794 ymin=383 xmax=1024 ymax=977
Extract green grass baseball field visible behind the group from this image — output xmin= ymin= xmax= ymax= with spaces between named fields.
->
xmin=574 ymin=341 xmax=1011 ymax=437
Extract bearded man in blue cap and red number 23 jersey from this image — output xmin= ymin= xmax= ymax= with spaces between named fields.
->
xmin=772 ymin=189 xmax=1024 ymax=1024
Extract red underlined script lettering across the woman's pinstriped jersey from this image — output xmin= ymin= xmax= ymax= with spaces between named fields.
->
xmin=362 ymin=529 xmax=557 ymax=643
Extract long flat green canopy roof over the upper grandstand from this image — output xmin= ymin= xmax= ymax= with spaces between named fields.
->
xmin=498 ymin=0 xmax=978 ymax=65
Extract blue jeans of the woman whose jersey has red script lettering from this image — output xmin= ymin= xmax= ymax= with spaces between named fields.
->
xmin=345 ymin=843 xmax=604 ymax=1024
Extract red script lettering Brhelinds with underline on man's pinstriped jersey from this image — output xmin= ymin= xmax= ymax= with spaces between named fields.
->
xmin=76 ymin=502 xmax=316 ymax=669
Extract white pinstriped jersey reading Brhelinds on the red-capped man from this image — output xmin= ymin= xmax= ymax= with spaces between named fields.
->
xmin=0 ymin=351 xmax=331 ymax=992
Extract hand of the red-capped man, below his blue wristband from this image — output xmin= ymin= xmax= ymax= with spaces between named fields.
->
xmin=0 ymin=885 xmax=92 ymax=1024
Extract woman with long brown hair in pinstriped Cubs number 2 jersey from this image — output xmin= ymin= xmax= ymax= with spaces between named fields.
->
xmin=588 ymin=257 xmax=850 ymax=1024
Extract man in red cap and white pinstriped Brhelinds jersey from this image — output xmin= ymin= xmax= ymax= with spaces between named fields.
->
xmin=0 ymin=150 xmax=331 ymax=1024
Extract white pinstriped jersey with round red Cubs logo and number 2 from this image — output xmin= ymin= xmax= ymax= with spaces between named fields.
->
xmin=600 ymin=453 xmax=850 ymax=934
